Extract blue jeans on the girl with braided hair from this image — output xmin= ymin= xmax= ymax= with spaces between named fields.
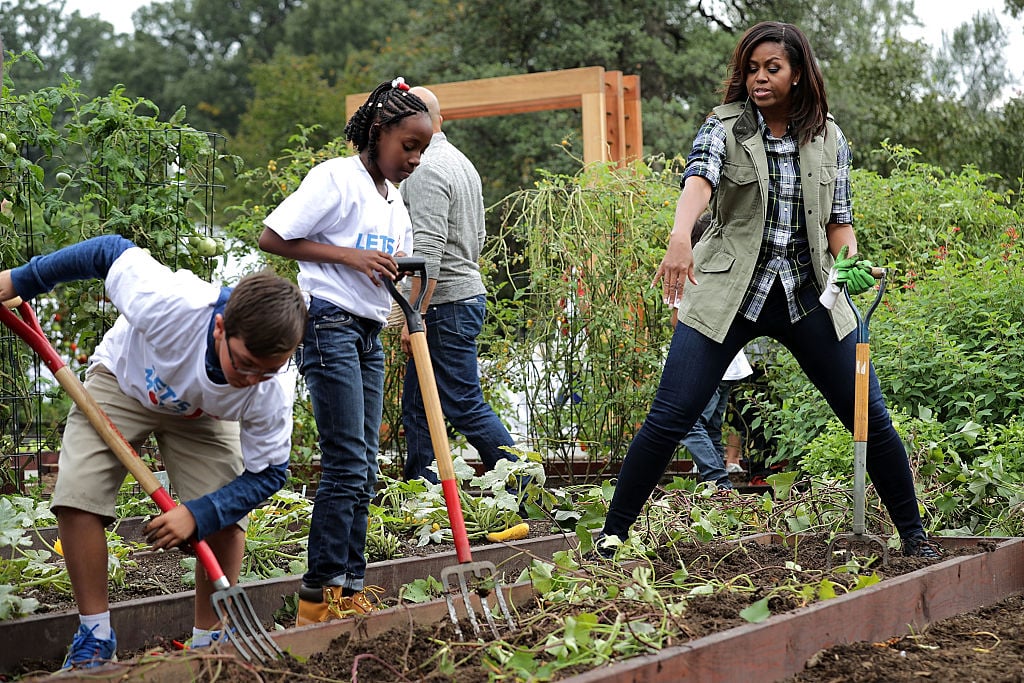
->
xmin=297 ymin=298 xmax=384 ymax=591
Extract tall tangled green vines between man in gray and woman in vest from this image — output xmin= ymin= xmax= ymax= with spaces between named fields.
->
xmin=482 ymin=156 xmax=676 ymax=459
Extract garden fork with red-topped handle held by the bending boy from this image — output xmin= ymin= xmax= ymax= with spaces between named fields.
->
xmin=0 ymin=299 xmax=284 ymax=663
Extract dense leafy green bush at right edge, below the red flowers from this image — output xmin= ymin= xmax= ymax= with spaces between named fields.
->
xmin=871 ymin=226 xmax=1024 ymax=424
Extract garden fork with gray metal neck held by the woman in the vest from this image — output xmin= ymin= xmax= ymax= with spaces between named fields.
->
xmin=826 ymin=267 xmax=889 ymax=566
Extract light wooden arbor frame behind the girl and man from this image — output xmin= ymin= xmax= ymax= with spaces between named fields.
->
xmin=345 ymin=67 xmax=643 ymax=165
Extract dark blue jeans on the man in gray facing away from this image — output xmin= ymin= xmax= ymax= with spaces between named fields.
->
xmin=401 ymin=295 xmax=517 ymax=483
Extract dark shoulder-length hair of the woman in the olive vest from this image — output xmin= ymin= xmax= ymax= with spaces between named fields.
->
xmin=722 ymin=22 xmax=828 ymax=144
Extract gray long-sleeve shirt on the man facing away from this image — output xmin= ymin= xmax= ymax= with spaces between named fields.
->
xmin=401 ymin=132 xmax=486 ymax=304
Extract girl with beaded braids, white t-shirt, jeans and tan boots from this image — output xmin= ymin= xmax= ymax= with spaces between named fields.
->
xmin=259 ymin=78 xmax=433 ymax=626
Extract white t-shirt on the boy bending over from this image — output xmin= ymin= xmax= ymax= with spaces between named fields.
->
xmin=91 ymin=248 xmax=296 ymax=472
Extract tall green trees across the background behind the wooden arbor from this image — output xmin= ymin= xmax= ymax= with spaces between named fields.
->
xmin=0 ymin=0 xmax=1024 ymax=214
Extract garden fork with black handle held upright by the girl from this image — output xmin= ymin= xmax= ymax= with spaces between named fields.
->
xmin=384 ymin=256 xmax=515 ymax=638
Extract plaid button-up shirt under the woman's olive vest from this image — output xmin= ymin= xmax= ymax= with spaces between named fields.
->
xmin=683 ymin=112 xmax=853 ymax=323
